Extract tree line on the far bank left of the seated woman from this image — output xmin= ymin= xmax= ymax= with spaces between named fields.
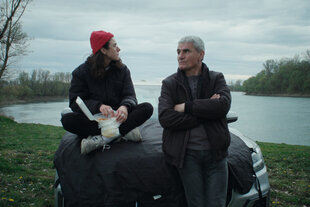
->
xmin=0 ymin=69 xmax=71 ymax=102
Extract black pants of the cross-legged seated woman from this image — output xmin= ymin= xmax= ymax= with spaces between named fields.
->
xmin=61 ymin=103 xmax=153 ymax=138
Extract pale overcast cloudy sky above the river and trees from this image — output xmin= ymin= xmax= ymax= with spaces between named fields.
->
xmin=19 ymin=0 xmax=310 ymax=83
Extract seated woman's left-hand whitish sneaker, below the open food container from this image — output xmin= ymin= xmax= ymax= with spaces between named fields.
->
xmin=81 ymin=135 xmax=119 ymax=154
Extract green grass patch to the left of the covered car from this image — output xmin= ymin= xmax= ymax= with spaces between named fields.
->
xmin=0 ymin=116 xmax=65 ymax=207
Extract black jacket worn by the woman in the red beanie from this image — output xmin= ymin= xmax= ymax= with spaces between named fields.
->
xmin=69 ymin=62 xmax=137 ymax=114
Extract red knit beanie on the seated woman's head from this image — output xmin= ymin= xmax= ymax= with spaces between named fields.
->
xmin=90 ymin=30 xmax=114 ymax=54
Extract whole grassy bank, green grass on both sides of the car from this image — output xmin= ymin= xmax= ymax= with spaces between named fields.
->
xmin=0 ymin=116 xmax=310 ymax=207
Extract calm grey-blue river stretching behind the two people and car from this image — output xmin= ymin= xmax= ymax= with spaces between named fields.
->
xmin=0 ymin=85 xmax=310 ymax=146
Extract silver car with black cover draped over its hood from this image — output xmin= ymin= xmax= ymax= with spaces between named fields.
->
xmin=54 ymin=113 xmax=270 ymax=207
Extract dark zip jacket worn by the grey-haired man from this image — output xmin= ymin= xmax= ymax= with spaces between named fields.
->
xmin=158 ymin=64 xmax=231 ymax=168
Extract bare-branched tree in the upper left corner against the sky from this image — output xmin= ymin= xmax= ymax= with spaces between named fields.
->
xmin=0 ymin=0 xmax=31 ymax=79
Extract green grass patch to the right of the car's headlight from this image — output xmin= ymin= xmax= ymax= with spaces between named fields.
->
xmin=258 ymin=142 xmax=310 ymax=207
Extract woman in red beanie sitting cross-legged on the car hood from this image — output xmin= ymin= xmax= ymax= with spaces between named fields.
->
xmin=61 ymin=31 xmax=153 ymax=154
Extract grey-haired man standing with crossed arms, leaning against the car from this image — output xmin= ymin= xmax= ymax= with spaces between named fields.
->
xmin=158 ymin=36 xmax=231 ymax=207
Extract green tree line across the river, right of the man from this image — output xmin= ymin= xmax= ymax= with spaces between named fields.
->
xmin=230 ymin=50 xmax=310 ymax=96
